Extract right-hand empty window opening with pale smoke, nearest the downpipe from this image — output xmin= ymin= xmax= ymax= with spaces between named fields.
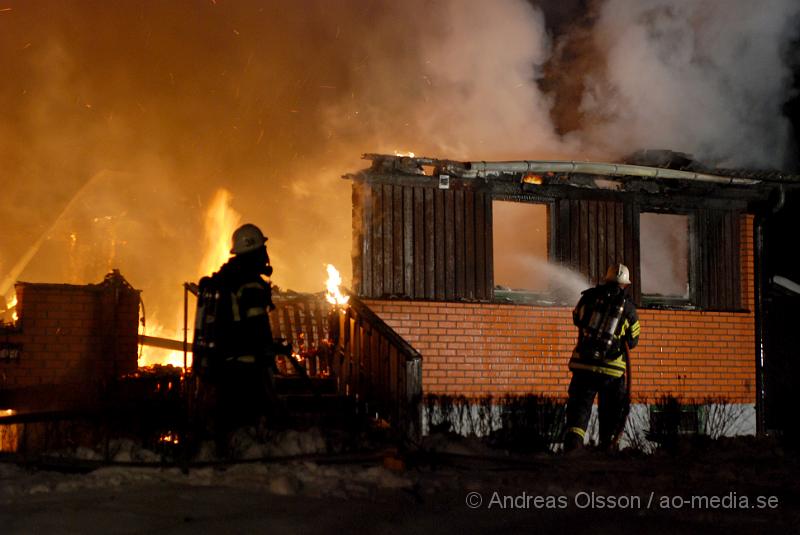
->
xmin=639 ymin=212 xmax=692 ymax=304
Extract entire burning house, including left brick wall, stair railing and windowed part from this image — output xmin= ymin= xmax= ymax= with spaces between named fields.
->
xmin=0 ymin=151 xmax=800 ymax=452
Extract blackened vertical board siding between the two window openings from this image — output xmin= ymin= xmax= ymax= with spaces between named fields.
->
xmin=554 ymin=199 xmax=639 ymax=300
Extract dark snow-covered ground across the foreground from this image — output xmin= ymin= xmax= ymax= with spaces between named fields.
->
xmin=0 ymin=429 xmax=800 ymax=535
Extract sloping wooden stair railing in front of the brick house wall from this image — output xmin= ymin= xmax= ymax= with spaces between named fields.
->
xmin=330 ymin=296 xmax=422 ymax=439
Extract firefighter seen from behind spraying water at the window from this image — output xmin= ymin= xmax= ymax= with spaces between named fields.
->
xmin=564 ymin=264 xmax=640 ymax=451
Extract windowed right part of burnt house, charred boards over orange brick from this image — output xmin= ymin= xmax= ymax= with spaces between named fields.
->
xmin=345 ymin=151 xmax=800 ymax=442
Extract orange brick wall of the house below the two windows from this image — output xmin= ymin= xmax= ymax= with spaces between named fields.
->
xmin=367 ymin=216 xmax=755 ymax=403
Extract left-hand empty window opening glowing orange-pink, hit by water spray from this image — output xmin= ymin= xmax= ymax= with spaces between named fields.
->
xmin=492 ymin=200 xmax=551 ymax=300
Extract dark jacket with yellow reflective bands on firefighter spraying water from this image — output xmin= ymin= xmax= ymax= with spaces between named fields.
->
xmin=569 ymin=283 xmax=640 ymax=377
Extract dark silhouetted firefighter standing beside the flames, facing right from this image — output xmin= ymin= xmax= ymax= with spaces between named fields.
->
xmin=195 ymin=224 xmax=277 ymax=453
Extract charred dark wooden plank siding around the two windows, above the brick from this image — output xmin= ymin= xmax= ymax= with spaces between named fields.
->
xmin=352 ymin=175 xmax=744 ymax=311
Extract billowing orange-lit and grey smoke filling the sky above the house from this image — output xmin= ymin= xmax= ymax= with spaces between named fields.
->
xmin=0 ymin=0 xmax=798 ymax=336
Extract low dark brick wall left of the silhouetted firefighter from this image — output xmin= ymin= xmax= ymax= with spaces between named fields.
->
xmin=0 ymin=273 xmax=139 ymax=408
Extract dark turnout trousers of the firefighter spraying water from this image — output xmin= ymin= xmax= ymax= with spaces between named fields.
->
xmin=564 ymin=370 xmax=627 ymax=450
